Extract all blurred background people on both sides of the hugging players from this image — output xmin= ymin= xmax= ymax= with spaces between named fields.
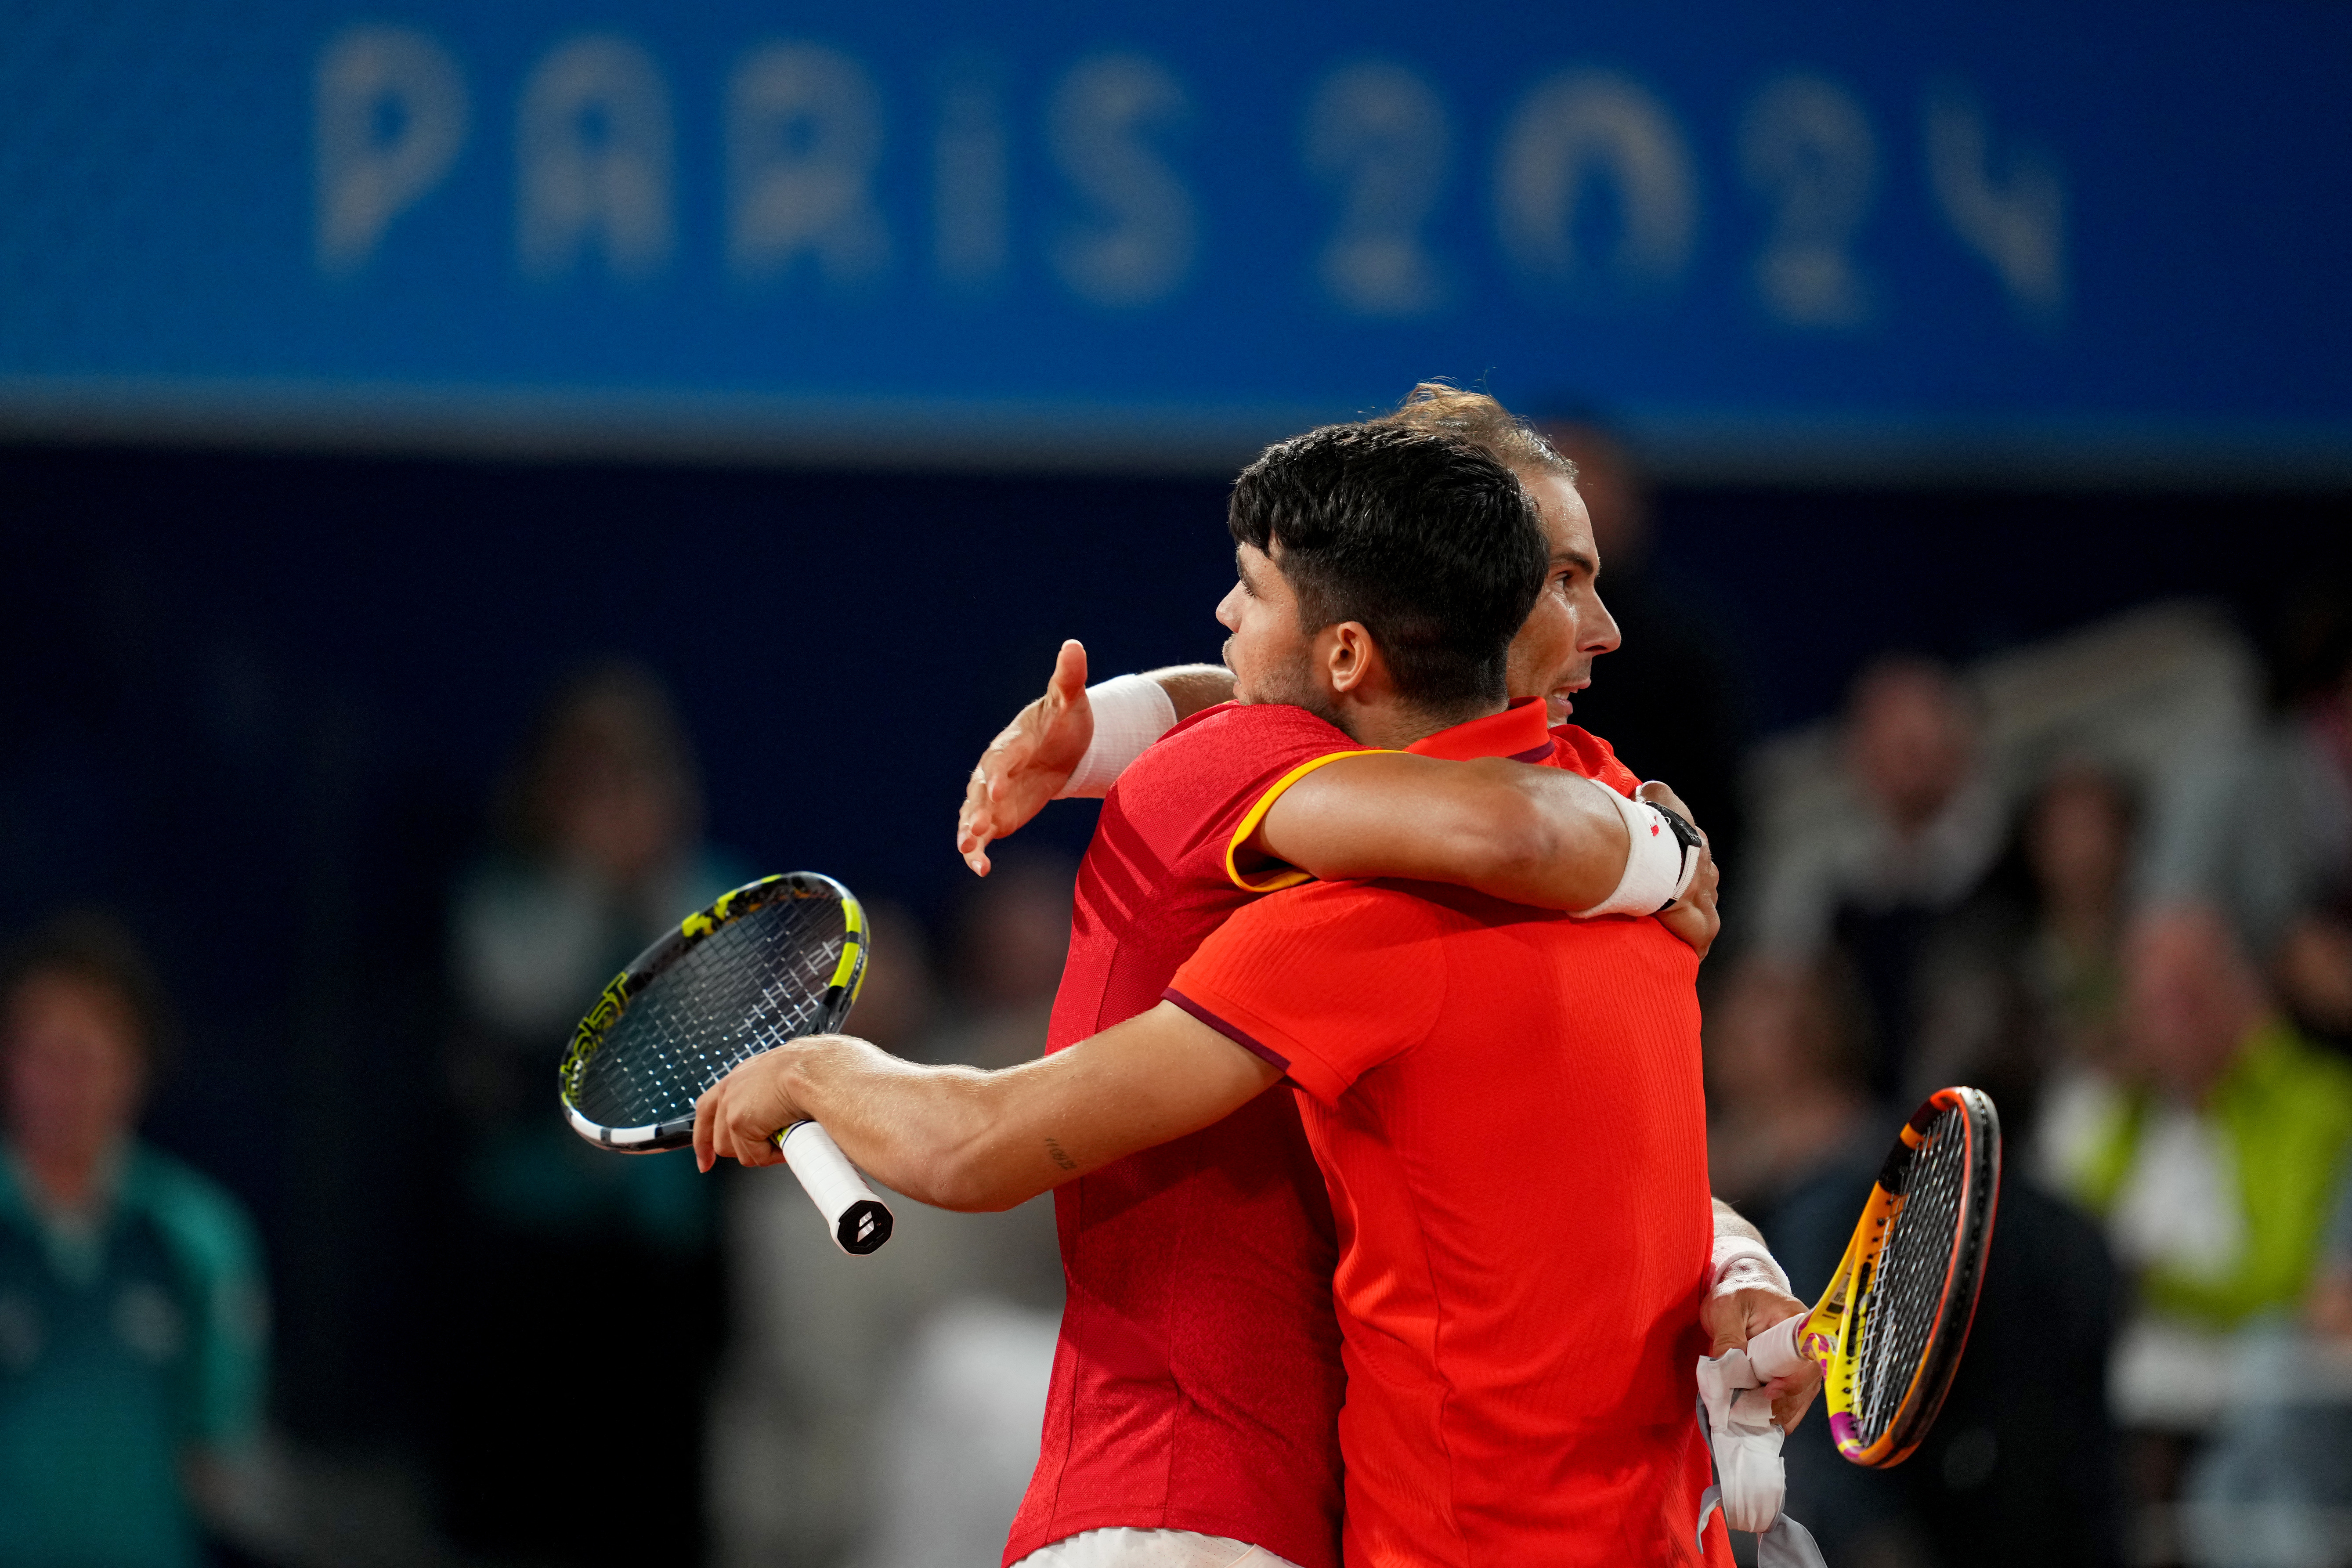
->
xmin=0 ymin=446 xmax=2352 ymax=1568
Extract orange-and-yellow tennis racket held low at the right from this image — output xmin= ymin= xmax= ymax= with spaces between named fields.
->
xmin=1748 ymin=1088 xmax=2002 ymax=1469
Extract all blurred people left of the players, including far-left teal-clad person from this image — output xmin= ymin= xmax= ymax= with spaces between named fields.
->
xmin=0 ymin=663 xmax=1075 ymax=1568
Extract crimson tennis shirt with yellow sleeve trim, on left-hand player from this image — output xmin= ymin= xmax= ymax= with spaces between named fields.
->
xmin=1004 ymin=703 xmax=1646 ymax=1568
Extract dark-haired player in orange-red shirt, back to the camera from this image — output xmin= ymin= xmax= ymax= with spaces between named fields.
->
xmin=696 ymin=428 xmax=1795 ymax=1563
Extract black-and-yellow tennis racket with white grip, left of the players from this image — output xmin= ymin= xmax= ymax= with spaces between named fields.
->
xmin=560 ymin=872 xmax=892 ymax=1253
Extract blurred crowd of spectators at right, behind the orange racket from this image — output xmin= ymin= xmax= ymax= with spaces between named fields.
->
xmin=1708 ymin=604 xmax=2352 ymax=1568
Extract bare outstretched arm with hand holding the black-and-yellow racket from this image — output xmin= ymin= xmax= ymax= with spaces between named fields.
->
xmin=694 ymin=1001 xmax=1282 ymax=1210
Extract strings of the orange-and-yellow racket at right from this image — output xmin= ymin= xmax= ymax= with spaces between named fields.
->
xmin=1856 ymin=1109 xmax=1969 ymax=1443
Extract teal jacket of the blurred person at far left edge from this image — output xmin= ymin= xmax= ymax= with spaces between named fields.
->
xmin=0 ymin=1145 xmax=268 ymax=1568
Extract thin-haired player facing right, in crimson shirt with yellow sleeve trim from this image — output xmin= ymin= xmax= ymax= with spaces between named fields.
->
xmin=957 ymin=383 xmax=1804 ymax=1568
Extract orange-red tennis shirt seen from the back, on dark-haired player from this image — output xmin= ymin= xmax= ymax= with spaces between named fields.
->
xmin=1167 ymin=804 xmax=1731 ymax=1568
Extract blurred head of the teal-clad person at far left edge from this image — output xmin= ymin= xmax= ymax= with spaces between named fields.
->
xmin=0 ymin=975 xmax=146 ymax=1185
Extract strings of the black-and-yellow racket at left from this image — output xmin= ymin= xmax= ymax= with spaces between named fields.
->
xmin=571 ymin=898 xmax=847 ymax=1128
